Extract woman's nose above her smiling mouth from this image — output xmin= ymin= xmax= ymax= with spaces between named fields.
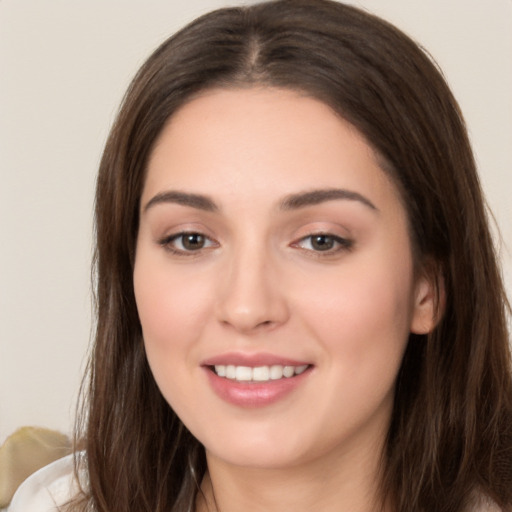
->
xmin=217 ymin=247 xmax=289 ymax=334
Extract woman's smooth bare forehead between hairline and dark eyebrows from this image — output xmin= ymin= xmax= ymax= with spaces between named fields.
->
xmin=143 ymin=88 xmax=395 ymax=210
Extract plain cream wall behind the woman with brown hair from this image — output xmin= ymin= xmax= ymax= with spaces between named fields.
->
xmin=0 ymin=0 xmax=512 ymax=443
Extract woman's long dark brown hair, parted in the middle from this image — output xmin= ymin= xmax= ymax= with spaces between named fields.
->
xmin=77 ymin=0 xmax=512 ymax=512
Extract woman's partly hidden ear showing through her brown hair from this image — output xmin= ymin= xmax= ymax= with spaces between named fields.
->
xmin=411 ymin=271 xmax=445 ymax=334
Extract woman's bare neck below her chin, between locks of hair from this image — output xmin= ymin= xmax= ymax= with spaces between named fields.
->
xmin=196 ymin=436 xmax=387 ymax=512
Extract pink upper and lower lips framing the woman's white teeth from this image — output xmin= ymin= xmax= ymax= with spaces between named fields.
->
xmin=201 ymin=353 xmax=313 ymax=408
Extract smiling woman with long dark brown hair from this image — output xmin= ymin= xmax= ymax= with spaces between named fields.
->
xmin=9 ymin=0 xmax=512 ymax=512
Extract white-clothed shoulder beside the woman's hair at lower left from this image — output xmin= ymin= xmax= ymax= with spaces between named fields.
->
xmin=7 ymin=454 xmax=85 ymax=512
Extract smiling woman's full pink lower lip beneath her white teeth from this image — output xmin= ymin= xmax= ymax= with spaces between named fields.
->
xmin=205 ymin=367 xmax=311 ymax=407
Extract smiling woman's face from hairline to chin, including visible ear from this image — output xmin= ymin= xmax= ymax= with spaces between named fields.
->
xmin=134 ymin=88 xmax=432 ymax=468
